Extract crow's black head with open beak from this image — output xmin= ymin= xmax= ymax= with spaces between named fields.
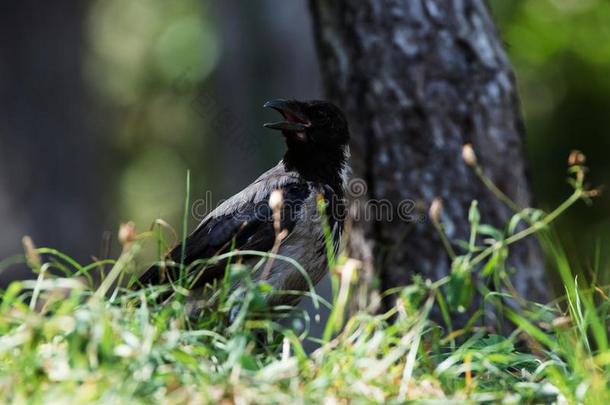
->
xmin=264 ymin=99 xmax=349 ymax=151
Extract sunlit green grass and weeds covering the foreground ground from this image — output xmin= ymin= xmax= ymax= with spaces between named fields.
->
xmin=0 ymin=154 xmax=610 ymax=404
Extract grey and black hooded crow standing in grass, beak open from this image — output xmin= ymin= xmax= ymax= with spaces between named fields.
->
xmin=140 ymin=99 xmax=349 ymax=305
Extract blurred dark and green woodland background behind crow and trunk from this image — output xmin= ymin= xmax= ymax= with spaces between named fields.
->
xmin=0 ymin=0 xmax=610 ymax=284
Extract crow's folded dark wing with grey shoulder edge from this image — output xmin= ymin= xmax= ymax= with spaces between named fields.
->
xmin=140 ymin=166 xmax=312 ymax=285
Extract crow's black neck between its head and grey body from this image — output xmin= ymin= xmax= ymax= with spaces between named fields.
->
xmin=283 ymin=147 xmax=348 ymax=194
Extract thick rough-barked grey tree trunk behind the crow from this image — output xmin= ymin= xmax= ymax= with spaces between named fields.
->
xmin=311 ymin=0 xmax=549 ymax=322
